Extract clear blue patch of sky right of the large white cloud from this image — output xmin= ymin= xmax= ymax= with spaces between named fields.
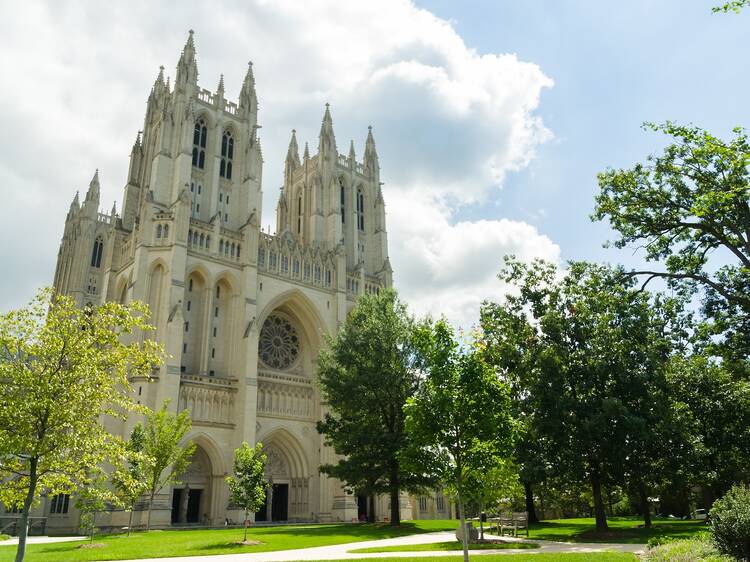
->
xmin=418 ymin=0 xmax=750 ymax=264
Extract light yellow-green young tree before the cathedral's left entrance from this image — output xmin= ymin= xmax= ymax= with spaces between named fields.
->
xmin=142 ymin=402 xmax=195 ymax=530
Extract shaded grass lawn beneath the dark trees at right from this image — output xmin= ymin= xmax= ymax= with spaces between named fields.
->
xmin=529 ymin=517 xmax=706 ymax=544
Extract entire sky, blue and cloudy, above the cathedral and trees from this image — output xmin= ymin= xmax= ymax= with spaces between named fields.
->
xmin=0 ymin=0 xmax=750 ymax=328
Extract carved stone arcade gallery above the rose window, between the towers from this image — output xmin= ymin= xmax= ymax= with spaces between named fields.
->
xmin=258 ymin=232 xmax=336 ymax=288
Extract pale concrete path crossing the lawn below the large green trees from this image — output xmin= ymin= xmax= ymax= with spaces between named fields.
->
xmin=117 ymin=532 xmax=645 ymax=562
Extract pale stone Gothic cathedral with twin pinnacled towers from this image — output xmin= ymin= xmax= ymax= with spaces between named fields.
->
xmin=39 ymin=31 xmax=458 ymax=532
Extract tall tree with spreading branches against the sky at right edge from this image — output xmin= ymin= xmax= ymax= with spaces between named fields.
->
xmin=592 ymin=122 xmax=750 ymax=376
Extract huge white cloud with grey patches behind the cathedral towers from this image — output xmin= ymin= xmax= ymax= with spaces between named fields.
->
xmin=0 ymin=0 xmax=559 ymax=323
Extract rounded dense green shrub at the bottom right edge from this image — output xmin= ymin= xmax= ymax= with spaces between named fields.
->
xmin=710 ymin=485 xmax=750 ymax=560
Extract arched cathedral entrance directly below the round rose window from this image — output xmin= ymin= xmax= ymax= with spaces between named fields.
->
xmin=255 ymin=430 xmax=310 ymax=521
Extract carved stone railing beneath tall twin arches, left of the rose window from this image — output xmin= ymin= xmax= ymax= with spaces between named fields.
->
xmin=179 ymin=374 xmax=237 ymax=427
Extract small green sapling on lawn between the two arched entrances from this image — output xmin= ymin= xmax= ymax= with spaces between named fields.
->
xmin=227 ymin=443 xmax=268 ymax=542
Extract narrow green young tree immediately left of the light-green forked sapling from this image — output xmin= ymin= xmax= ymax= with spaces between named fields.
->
xmin=112 ymin=424 xmax=153 ymax=536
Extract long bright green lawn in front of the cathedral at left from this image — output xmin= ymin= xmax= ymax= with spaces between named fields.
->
xmin=0 ymin=520 xmax=456 ymax=562
